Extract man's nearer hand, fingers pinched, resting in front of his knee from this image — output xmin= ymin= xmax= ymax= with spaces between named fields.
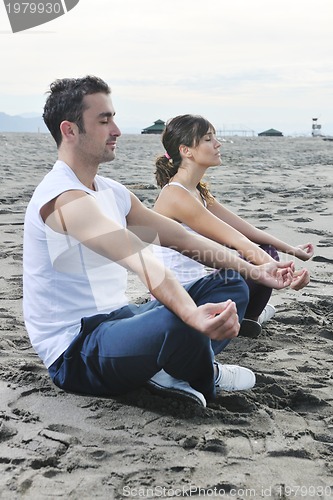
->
xmin=187 ymin=300 xmax=240 ymax=340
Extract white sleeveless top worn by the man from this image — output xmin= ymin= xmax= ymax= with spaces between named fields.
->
xmin=23 ymin=161 xmax=131 ymax=367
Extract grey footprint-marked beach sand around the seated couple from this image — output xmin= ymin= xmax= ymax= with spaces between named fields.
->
xmin=0 ymin=134 xmax=333 ymax=500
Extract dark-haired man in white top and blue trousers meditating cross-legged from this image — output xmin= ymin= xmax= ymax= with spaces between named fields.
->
xmin=23 ymin=76 xmax=293 ymax=406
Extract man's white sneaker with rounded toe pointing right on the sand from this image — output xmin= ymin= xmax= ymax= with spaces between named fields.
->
xmin=214 ymin=361 xmax=256 ymax=392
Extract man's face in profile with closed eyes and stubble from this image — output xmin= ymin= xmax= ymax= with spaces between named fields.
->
xmin=77 ymin=92 xmax=121 ymax=164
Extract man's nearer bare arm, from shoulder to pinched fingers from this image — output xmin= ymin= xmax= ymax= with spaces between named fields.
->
xmin=41 ymin=190 xmax=239 ymax=340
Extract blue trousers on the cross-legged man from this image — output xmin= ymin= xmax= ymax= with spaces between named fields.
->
xmin=49 ymin=270 xmax=248 ymax=398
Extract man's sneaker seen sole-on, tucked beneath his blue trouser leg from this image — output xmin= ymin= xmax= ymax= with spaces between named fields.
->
xmin=148 ymin=370 xmax=207 ymax=407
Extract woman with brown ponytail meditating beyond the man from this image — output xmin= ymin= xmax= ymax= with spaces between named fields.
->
xmin=154 ymin=115 xmax=314 ymax=337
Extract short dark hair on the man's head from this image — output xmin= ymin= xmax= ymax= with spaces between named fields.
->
xmin=43 ymin=75 xmax=111 ymax=147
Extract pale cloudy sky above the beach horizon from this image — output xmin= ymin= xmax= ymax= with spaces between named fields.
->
xmin=0 ymin=0 xmax=333 ymax=135
